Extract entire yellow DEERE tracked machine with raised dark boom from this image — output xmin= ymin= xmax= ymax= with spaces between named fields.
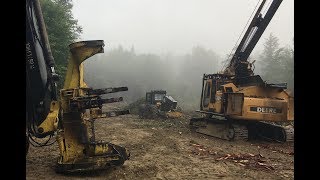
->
xmin=190 ymin=0 xmax=294 ymax=142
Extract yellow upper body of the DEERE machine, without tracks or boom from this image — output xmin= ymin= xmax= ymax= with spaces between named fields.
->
xmin=201 ymin=79 xmax=294 ymax=122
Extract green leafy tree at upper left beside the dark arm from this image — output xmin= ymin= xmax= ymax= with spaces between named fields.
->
xmin=40 ymin=0 xmax=82 ymax=89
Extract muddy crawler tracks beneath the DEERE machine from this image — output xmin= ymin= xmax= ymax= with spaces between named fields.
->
xmin=190 ymin=118 xmax=294 ymax=143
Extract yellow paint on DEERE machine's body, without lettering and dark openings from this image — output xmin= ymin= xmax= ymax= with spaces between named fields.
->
xmin=201 ymin=79 xmax=294 ymax=121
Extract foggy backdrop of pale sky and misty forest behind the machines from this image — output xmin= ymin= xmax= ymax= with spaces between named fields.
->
xmin=67 ymin=0 xmax=294 ymax=110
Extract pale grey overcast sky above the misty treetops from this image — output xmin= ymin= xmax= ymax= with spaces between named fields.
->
xmin=73 ymin=0 xmax=294 ymax=57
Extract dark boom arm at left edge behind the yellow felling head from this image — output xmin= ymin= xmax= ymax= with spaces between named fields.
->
xmin=26 ymin=0 xmax=58 ymax=139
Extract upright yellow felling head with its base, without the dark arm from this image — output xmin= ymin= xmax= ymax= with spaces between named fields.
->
xmin=38 ymin=40 xmax=130 ymax=172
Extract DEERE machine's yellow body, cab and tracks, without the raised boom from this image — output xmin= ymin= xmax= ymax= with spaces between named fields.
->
xmin=190 ymin=74 xmax=294 ymax=142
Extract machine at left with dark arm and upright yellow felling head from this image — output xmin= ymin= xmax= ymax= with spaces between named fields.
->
xmin=26 ymin=0 xmax=130 ymax=173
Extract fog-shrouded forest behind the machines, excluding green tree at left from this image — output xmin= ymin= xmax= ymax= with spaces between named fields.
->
xmin=84 ymin=34 xmax=294 ymax=110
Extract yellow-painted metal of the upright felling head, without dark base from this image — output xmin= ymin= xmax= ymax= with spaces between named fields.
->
xmin=57 ymin=41 xmax=126 ymax=165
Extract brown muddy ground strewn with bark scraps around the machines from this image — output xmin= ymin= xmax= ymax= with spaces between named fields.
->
xmin=26 ymin=109 xmax=294 ymax=179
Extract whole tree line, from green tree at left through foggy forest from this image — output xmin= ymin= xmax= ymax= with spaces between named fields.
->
xmin=41 ymin=0 xmax=294 ymax=110
